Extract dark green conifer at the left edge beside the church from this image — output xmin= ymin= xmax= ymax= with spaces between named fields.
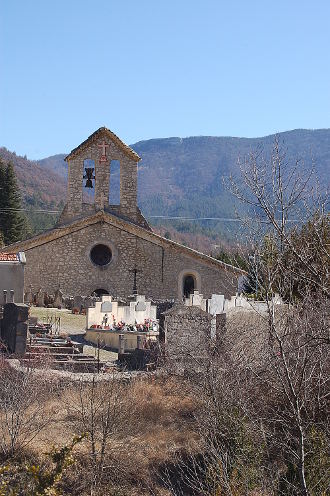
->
xmin=0 ymin=163 xmax=27 ymax=245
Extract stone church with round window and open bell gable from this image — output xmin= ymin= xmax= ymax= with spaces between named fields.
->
xmin=5 ymin=127 xmax=241 ymax=300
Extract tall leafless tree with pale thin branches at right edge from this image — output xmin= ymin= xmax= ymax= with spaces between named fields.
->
xmin=227 ymin=138 xmax=330 ymax=495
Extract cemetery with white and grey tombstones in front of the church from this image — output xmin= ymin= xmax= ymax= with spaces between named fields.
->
xmin=0 ymin=252 xmax=282 ymax=373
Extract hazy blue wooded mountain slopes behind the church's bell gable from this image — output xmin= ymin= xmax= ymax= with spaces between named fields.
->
xmin=0 ymin=129 xmax=330 ymax=248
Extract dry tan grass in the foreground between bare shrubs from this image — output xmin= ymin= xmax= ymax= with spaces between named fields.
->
xmin=4 ymin=378 xmax=198 ymax=496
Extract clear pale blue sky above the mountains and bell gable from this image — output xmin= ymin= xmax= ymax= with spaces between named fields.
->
xmin=0 ymin=0 xmax=330 ymax=159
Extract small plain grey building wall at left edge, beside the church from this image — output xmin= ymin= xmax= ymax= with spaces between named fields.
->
xmin=0 ymin=256 xmax=24 ymax=305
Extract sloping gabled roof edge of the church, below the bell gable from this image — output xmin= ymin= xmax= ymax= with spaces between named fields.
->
xmin=2 ymin=210 xmax=246 ymax=275
